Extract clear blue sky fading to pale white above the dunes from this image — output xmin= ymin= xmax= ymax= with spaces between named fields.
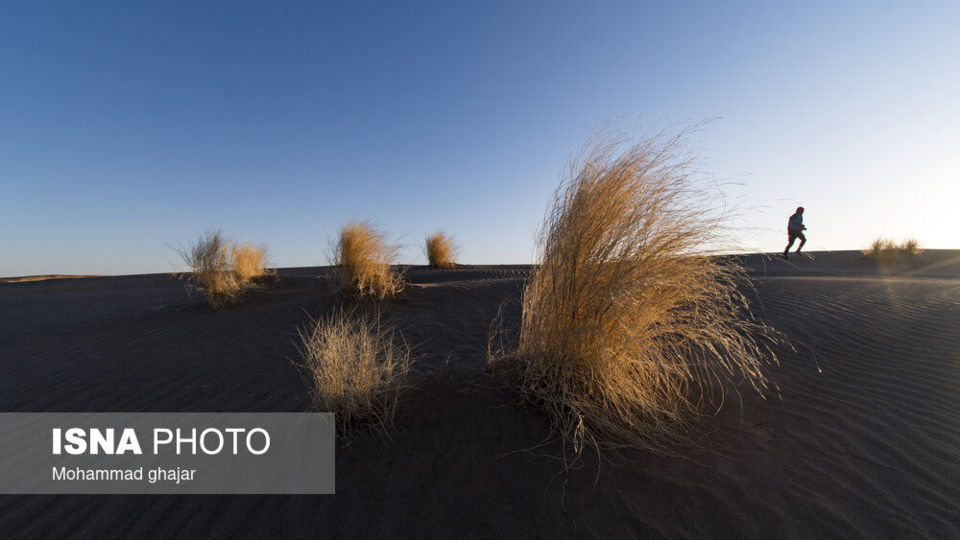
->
xmin=0 ymin=1 xmax=960 ymax=275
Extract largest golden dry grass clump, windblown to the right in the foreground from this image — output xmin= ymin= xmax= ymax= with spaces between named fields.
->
xmin=493 ymin=132 xmax=775 ymax=453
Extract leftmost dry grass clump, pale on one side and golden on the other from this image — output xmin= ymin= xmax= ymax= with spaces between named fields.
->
xmin=180 ymin=231 xmax=267 ymax=308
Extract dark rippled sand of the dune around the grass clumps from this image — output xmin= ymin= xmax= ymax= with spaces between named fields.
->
xmin=0 ymin=251 xmax=960 ymax=538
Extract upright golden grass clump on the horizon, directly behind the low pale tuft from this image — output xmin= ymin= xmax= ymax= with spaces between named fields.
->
xmin=333 ymin=222 xmax=404 ymax=300
